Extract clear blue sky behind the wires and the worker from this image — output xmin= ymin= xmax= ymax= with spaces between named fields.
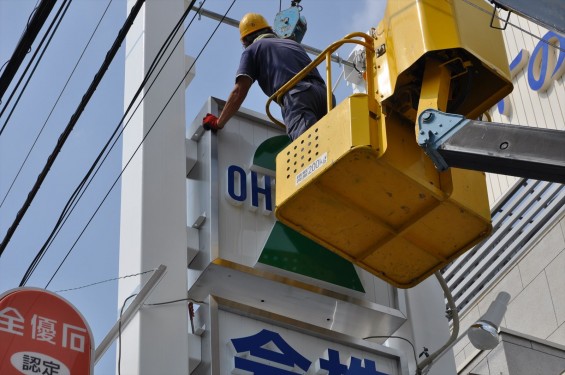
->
xmin=0 ymin=0 xmax=385 ymax=374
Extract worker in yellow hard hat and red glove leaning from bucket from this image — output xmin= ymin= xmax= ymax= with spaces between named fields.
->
xmin=202 ymin=13 xmax=335 ymax=140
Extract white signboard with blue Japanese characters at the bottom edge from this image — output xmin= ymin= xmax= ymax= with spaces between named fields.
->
xmin=218 ymin=310 xmax=401 ymax=375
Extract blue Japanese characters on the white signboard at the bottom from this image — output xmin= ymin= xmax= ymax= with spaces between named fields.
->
xmin=231 ymin=329 xmax=388 ymax=375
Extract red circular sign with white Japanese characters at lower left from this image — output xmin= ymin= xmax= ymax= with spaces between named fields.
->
xmin=0 ymin=288 xmax=94 ymax=375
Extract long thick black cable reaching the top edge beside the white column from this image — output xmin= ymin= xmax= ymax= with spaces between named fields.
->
xmin=0 ymin=0 xmax=145 ymax=256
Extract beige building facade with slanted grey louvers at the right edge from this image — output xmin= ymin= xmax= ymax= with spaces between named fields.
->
xmin=444 ymin=10 xmax=565 ymax=375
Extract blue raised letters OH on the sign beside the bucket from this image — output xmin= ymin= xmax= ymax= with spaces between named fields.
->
xmin=227 ymin=165 xmax=274 ymax=213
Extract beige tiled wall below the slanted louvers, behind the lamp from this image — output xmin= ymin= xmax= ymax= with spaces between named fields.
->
xmin=454 ymin=210 xmax=565 ymax=373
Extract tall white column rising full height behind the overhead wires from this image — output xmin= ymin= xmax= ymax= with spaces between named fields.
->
xmin=118 ymin=0 xmax=188 ymax=375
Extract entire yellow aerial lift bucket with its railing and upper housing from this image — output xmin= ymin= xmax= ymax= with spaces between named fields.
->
xmin=267 ymin=0 xmax=511 ymax=288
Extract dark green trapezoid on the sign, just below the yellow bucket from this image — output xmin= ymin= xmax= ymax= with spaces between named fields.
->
xmin=259 ymin=221 xmax=365 ymax=293
